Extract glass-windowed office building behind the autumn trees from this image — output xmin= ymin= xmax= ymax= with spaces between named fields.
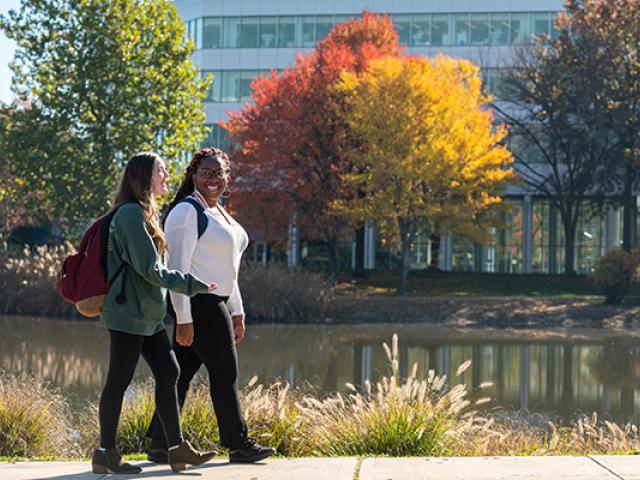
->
xmin=175 ymin=0 xmax=621 ymax=273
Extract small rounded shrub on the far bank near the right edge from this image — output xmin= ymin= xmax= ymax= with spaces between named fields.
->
xmin=590 ymin=248 xmax=638 ymax=303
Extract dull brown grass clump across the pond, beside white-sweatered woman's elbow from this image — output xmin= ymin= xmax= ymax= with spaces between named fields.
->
xmin=240 ymin=263 xmax=333 ymax=321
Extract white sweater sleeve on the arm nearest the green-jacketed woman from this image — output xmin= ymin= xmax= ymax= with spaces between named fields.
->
xmin=164 ymin=202 xmax=198 ymax=324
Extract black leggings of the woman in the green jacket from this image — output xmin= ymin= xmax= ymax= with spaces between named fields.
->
xmin=99 ymin=330 xmax=182 ymax=449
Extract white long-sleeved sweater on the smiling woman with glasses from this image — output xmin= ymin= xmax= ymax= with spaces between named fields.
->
xmin=164 ymin=195 xmax=249 ymax=323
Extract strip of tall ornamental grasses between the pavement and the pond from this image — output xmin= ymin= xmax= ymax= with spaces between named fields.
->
xmin=0 ymin=336 xmax=640 ymax=458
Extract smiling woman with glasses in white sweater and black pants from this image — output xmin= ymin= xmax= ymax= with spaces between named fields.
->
xmin=148 ymin=148 xmax=275 ymax=463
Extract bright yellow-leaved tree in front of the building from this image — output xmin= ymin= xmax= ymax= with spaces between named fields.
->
xmin=333 ymin=56 xmax=515 ymax=293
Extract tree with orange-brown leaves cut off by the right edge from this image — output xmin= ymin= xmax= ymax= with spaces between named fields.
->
xmin=558 ymin=0 xmax=640 ymax=251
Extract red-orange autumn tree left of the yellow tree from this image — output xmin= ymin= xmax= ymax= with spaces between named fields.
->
xmin=223 ymin=12 xmax=401 ymax=278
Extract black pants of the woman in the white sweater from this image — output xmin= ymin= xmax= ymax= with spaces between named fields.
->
xmin=147 ymin=294 xmax=247 ymax=449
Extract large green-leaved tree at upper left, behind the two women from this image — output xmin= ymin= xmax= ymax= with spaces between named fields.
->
xmin=0 ymin=0 xmax=208 ymax=232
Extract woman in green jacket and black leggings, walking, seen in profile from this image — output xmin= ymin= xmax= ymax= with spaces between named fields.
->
xmin=91 ymin=152 xmax=216 ymax=474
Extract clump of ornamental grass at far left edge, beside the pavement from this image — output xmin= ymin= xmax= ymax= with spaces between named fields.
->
xmin=0 ymin=375 xmax=71 ymax=457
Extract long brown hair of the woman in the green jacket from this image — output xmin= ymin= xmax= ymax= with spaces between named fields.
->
xmin=111 ymin=152 xmax=167 ymax=255
